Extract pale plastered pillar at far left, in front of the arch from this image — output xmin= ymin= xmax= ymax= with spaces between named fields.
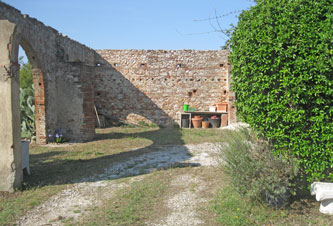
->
xmin=0 ymin=20 xmax=23 ymax=192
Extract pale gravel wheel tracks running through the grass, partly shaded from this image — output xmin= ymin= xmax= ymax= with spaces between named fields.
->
xmin=17 ymin=143 xmax=226 ymax=225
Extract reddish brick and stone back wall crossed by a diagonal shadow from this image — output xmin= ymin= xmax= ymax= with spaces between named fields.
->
xmin=95 ymin=50 xmax=229 ymax=125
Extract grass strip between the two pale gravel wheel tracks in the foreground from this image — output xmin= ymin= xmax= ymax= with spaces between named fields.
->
xmin=77 ymin=172 xmax=169 ymax=225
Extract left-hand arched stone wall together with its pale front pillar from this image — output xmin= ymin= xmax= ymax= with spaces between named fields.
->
xmin=0 ymin=2 xmax=97 ymax=191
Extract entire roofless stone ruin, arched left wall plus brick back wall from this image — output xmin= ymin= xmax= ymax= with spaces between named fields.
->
xmin=0 ymin=2 xmax=234 ymax=191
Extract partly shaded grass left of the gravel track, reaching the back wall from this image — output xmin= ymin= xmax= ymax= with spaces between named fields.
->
xmin=0 ymin=126 xmax=221 ymax=225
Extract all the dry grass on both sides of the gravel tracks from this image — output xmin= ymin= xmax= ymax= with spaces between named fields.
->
xmin=0 ymin=127 xmax=333 ymax=225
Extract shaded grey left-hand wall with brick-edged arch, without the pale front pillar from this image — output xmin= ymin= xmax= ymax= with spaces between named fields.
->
xmin=0 ymin=2 xmax=97 ymax=143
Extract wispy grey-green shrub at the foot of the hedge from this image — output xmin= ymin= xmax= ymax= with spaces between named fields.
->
xmin=222 ymin=129 xmax=296 ymax=207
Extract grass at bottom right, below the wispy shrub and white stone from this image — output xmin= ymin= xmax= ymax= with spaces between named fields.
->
xmin=212 ymin=182 xmax=333 ymax=226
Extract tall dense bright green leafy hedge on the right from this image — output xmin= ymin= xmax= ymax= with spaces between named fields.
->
xmin=230 ymin=0 xmax=333 ymax=181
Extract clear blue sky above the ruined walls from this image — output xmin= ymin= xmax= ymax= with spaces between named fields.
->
xmin=3 ymin=0 xmax=254 ymax=50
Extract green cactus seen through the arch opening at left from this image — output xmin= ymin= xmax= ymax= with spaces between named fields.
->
xmin=20 ymin=86 xmax=36 ymax=139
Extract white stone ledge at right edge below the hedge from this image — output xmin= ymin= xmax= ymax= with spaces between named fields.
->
xmin=311 ymin=182 xmax=333 ymax=215
